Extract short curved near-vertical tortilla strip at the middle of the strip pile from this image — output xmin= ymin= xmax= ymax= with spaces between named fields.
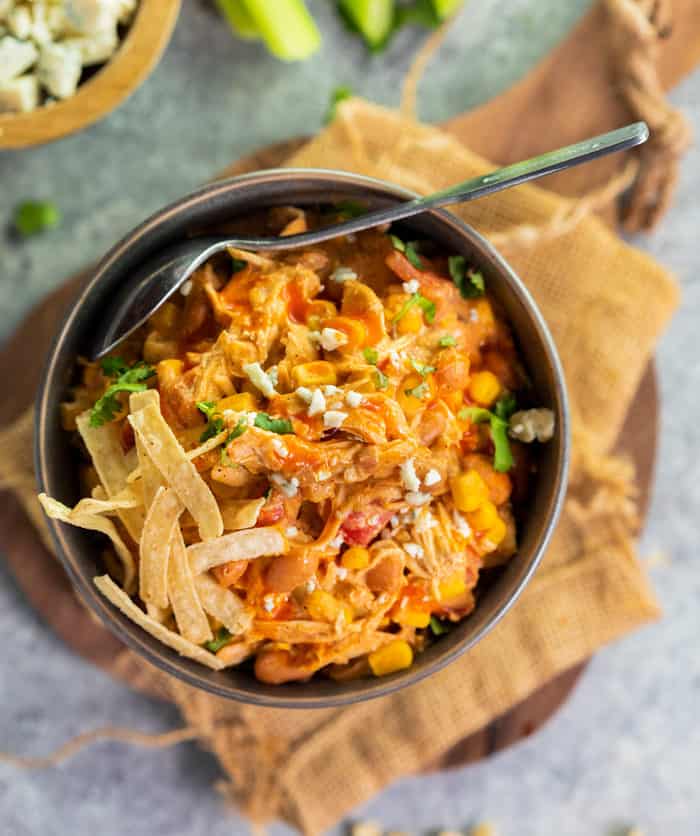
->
xmin=139 ymin=485 xmax=185 ymax=609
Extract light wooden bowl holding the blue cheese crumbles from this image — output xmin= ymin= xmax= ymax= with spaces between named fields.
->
xmin=0 ymin=0 xmax=181 ymax=149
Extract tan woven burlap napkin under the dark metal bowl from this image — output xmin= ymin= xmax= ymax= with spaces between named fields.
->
xmin=0 ymin=93 xmax=677 ymax=834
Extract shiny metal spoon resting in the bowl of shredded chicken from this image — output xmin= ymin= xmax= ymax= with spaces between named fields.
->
xmin=89 ymin=122 xmax=649 ymax=360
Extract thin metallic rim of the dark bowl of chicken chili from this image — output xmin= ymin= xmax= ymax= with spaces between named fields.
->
xmin=34 ymin=168 xmax=571 ymax=709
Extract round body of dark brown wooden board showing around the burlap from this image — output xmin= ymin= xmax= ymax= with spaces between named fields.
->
xmin=0 ymin=140 xmax=659 ymax=769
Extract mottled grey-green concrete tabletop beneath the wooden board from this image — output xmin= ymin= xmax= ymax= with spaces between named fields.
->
xmin=5 ymin=0 xmax=700 ymax=836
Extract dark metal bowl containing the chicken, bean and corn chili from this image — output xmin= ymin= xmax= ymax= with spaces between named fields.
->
xmin=35 ymin=169 xmax=569 ymax=708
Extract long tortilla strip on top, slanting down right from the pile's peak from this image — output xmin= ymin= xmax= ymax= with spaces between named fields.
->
xmin=129 ymin=403 xmax=224 ymax=540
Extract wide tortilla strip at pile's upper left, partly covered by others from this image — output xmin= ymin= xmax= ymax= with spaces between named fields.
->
xmin=75 ymin=410 xmax=145 ymax=543
